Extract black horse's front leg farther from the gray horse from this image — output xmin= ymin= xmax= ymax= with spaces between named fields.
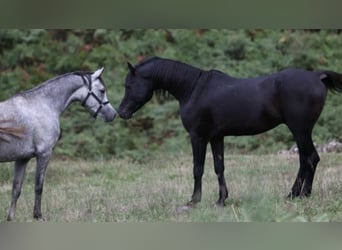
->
xmin=210 ymin=137 xmax=228 ymax=206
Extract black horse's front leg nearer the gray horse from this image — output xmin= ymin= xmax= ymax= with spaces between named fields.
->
xmin=187 ymin=136 xmax=208 ymax=206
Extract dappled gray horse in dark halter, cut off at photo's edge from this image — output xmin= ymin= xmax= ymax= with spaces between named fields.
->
xmin=0 ymin=68 xmax=116 ymax=221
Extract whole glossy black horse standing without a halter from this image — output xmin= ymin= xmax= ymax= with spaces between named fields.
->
xmin=118 ymin=57 xmax=342 ymax=206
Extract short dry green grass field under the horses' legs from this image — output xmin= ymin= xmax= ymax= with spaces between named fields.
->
xmin=0 ymin=154 xmax=342 ymax=222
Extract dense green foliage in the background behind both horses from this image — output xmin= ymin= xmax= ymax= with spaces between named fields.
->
xmin=0 ymin=29 xmax=342 ymax=159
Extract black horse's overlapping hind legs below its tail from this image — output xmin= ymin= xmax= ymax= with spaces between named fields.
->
xmin=289 ymin=133 xmax=320 ymax=198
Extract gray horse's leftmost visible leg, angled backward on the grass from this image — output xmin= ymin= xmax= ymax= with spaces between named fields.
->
xmin=7 ymin=160 xmax=29 ymax=221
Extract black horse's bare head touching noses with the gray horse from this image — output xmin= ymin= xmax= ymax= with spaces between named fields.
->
xmin=118 ymin=63 xmax=153 ymax=119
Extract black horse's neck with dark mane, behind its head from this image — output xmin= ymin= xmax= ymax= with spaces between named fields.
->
xmin=139 ymin=58 xmax=204 ymax=102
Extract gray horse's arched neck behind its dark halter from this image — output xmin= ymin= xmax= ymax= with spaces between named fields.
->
xmin=18 ymin=73 xmax=84 ymax=116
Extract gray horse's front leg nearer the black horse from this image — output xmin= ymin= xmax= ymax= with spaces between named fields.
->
xmin=33 ymin=152 xmax=51 ymax=220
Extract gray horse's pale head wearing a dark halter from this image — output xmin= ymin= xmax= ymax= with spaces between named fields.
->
xmin=82 ymin=68 xmax=116 ymax=122
